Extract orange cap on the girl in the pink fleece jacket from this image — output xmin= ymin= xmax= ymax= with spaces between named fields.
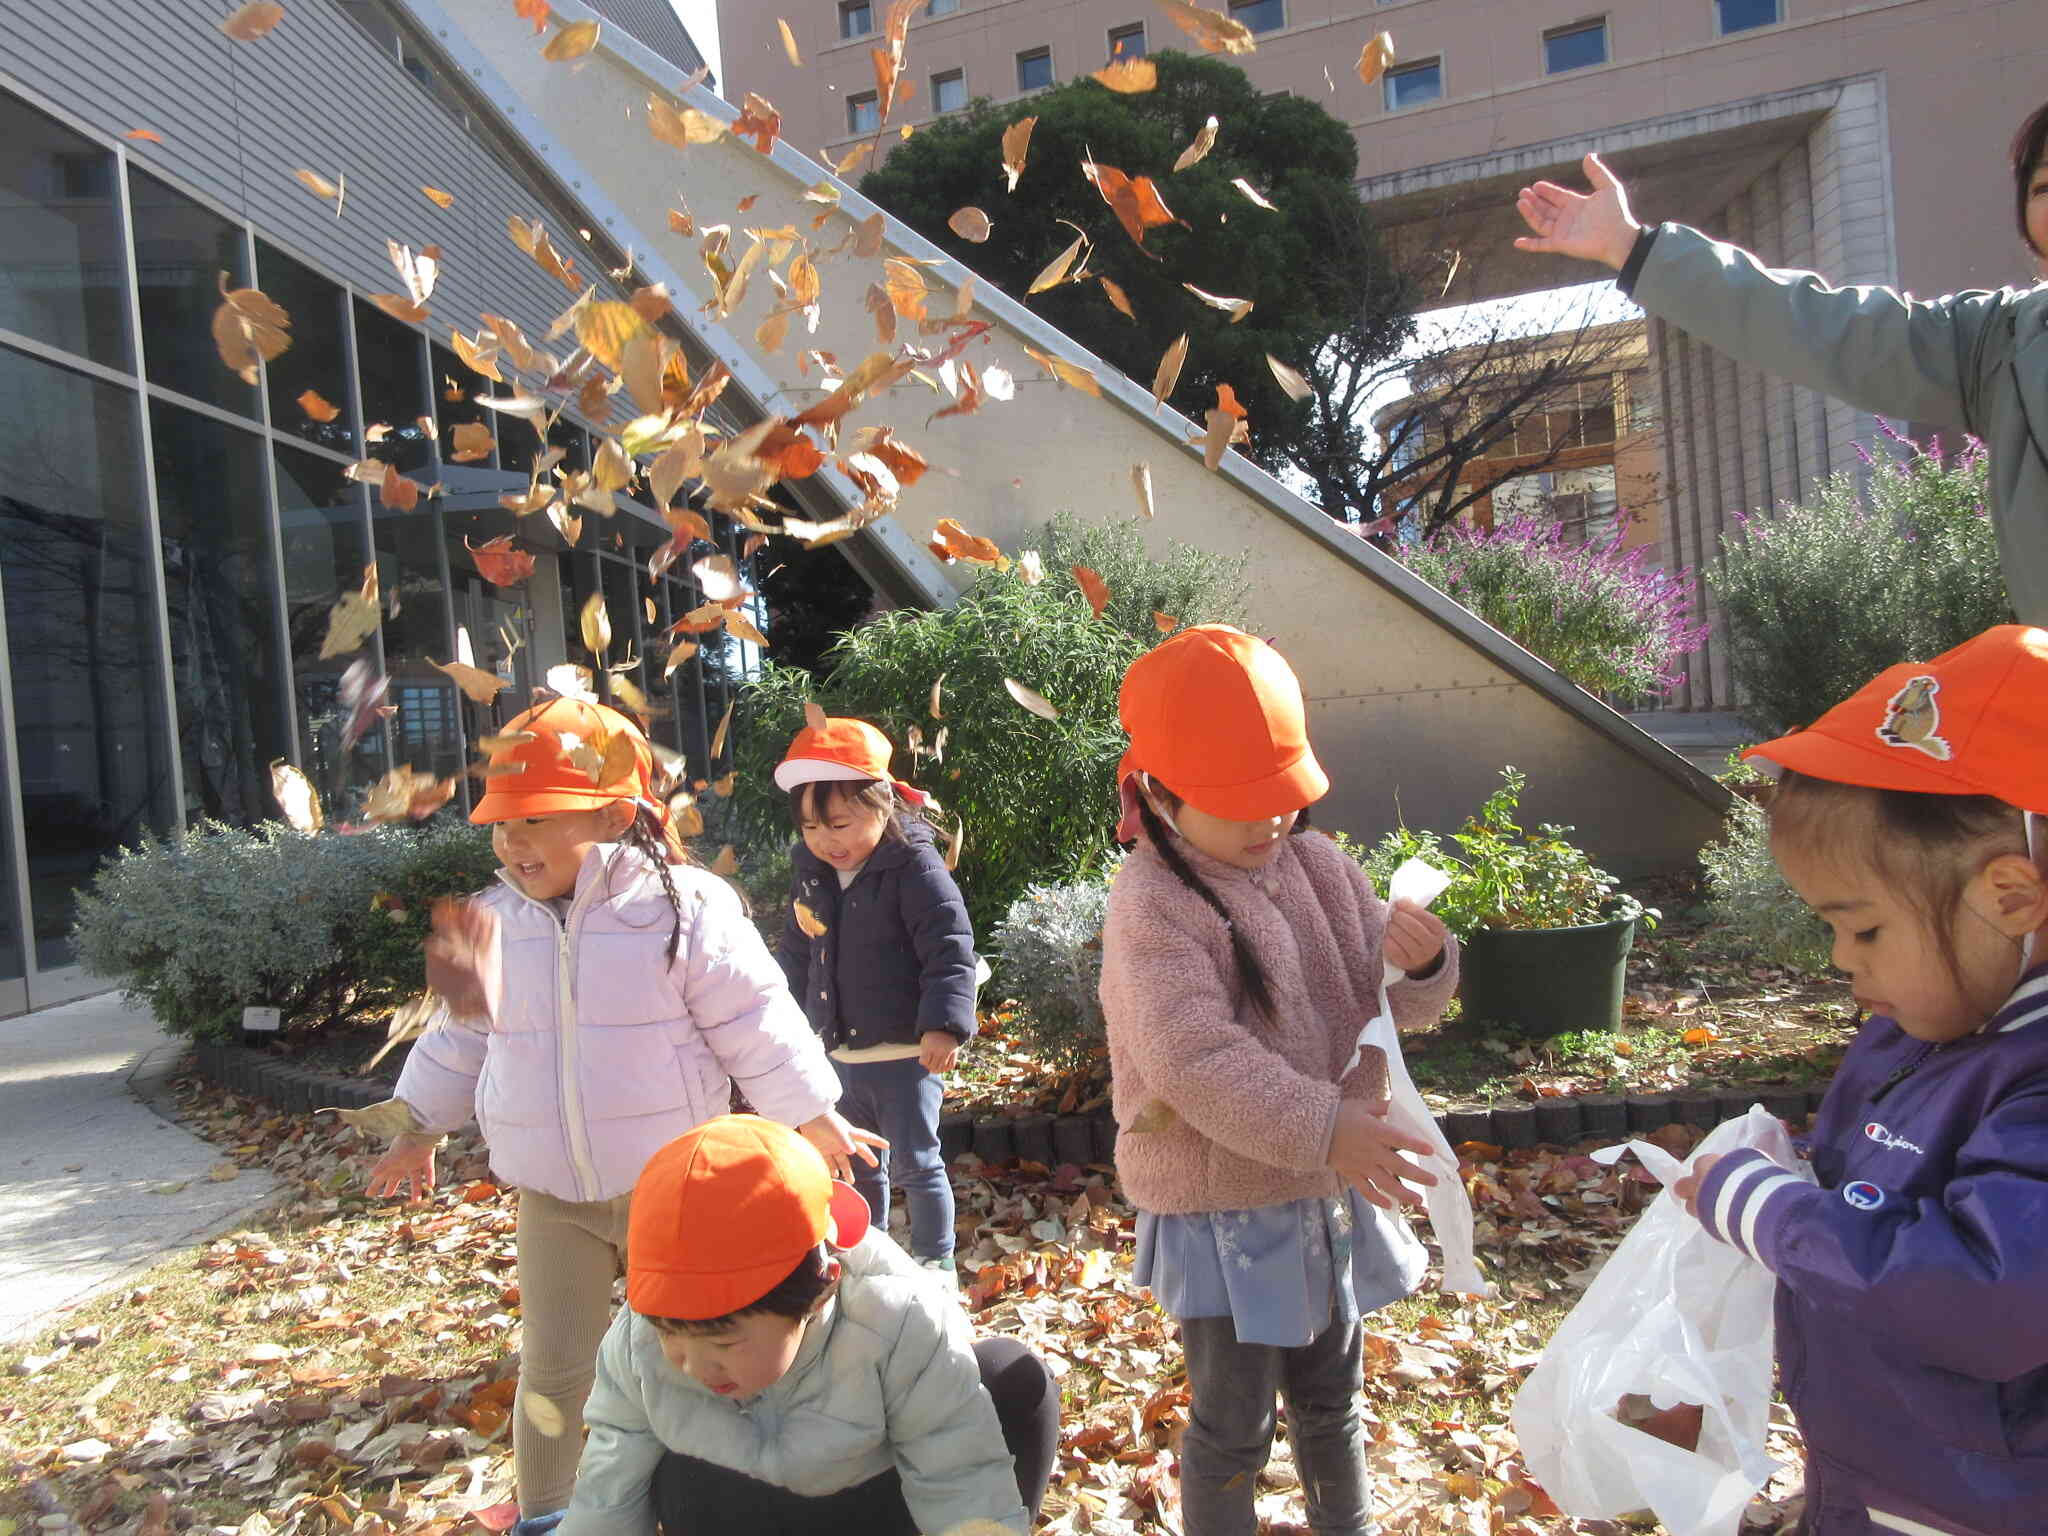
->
xmin=1116 ymin=625 xmax=1329 ymax=821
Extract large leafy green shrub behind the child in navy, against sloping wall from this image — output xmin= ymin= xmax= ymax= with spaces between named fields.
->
xmin=731 ymin=522 xmax=1245 ymax=934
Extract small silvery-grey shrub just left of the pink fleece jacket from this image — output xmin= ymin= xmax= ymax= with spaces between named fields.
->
xmin=993 ymin=868 xmax=1122 ymax=1069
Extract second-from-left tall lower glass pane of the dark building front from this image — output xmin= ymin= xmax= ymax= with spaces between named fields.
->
xmin=150 ymin=401 xmax=291 ymax=825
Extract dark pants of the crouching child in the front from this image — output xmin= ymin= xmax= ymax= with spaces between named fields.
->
xmin=653 ymin=1337 xmax=1059 ymax=1536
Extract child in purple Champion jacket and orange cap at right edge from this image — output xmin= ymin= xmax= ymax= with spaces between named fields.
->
xmin=1675 ymin=625 xmax=2048 ymax=1536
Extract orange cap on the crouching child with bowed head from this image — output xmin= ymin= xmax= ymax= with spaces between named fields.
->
xmin=627 ymin=1114 xmax=868 ymax=1321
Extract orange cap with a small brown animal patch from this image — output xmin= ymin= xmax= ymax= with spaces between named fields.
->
xmin=1743 ymin=625 xmax=2048 ymax=813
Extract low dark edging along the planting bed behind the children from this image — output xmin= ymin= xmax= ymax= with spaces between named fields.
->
xmin=193 ymin=1040 xmax=1827 ymax=1167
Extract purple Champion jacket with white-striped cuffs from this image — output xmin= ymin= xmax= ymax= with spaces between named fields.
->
xmin=1698 ymin=965 xmax=2048 ymax=1536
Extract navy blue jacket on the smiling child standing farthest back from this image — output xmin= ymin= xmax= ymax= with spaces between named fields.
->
xmin=776 ymin=817 xmax=975 ymax=1051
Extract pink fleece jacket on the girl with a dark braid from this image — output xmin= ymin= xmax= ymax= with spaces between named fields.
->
xmin=1102 ymin=831 xmax=1458 ymax=1214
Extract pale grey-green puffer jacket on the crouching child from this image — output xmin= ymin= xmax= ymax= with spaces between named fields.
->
xmin=557 ymin=1231 xmax=1030 ymax=1536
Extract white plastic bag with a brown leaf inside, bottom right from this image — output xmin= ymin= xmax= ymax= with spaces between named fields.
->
xmin=1513 ymin=1106 xmax=1812 ymax=1536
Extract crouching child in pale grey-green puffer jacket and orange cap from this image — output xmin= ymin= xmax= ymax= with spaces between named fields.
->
xmin=559 ymin=1114 xmax=1059 ymax=1536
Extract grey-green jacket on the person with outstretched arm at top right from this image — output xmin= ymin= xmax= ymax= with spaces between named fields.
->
xmin=1620 ymin=223 xmax=2048 ymax=625
